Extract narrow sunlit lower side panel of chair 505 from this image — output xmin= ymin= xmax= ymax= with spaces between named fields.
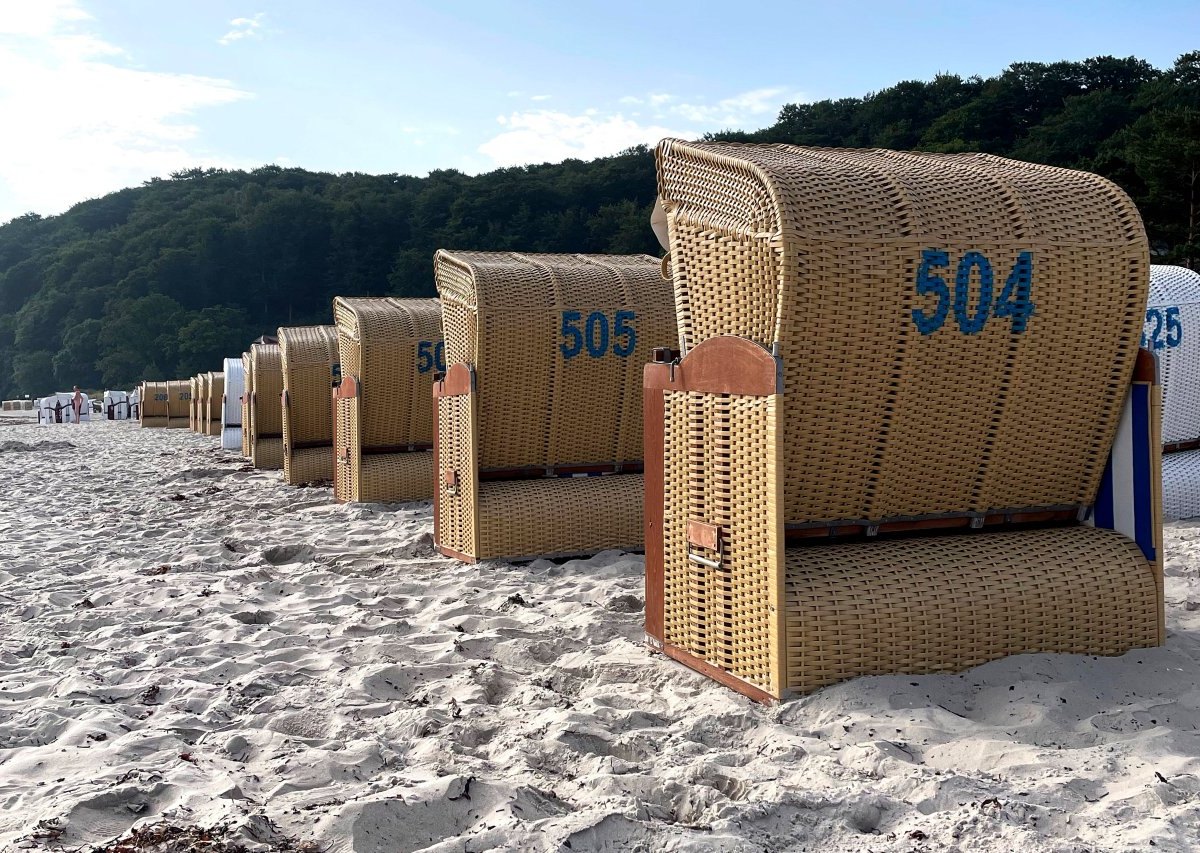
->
xmin=433 ymin=394 xmax=479 ymax=557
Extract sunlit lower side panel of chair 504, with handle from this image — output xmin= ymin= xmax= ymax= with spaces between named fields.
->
xmin=662 ymin=391 xmax=782 ymax=693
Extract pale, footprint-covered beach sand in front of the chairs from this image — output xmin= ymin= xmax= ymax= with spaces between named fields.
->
xmin=0 ymin=413 xmax=1200 ymax=853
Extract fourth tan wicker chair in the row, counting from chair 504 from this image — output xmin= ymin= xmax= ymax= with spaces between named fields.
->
xmin=280 ymin=326 xmax=337 ymax=486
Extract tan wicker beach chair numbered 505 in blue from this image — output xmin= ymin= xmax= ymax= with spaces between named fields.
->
xmin=433 ymin=251 xmax=676 ymax=561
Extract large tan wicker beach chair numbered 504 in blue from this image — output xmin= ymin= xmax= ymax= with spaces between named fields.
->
xmin=646 ymin=140 xmax=1163 ymax=701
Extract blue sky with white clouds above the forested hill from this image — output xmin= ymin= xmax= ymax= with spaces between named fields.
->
xmin=0 ymin=0 xmax=1200 ymax=223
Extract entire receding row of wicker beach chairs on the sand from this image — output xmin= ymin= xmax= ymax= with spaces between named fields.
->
xmin=124 ymin=140 xmax=1200 ymax=701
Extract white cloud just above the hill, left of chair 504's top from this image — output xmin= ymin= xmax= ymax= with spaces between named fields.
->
xmin=479 ymin=109 xmax=696 ymax=166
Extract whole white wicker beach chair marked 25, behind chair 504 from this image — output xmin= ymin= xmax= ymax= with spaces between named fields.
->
xmin=1141 ymin=264 xmax=1200 ymax=521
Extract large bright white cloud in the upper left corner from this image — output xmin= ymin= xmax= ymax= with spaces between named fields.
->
xmin=0 ymin=0 xmax=250 ymax=222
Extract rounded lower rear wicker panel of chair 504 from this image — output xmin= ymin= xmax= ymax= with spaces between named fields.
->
xmin=786 ymin=527 xmax=1158 ymax=691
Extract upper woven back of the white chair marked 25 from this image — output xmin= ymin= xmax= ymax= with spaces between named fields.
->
xmin=1141 ymin=264 xmax=1200 ymax=444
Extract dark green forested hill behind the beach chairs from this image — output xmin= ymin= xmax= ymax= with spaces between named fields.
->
xmin=0 ymin=52 xmax=1200 ymax=398
